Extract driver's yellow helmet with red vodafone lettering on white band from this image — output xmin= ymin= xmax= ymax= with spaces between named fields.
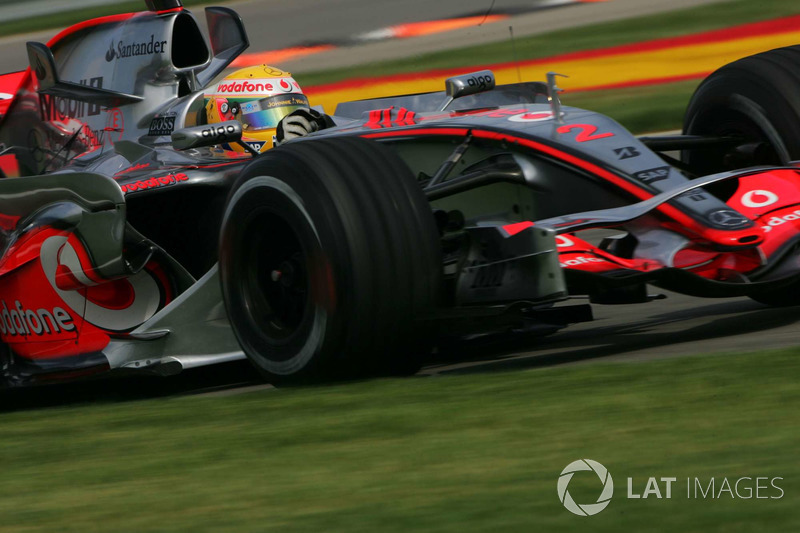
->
xmin=205 ymin=65 xmax=309 ymax=152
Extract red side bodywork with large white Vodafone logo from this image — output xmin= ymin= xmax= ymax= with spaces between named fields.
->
xmin=0 ymin=227 xmax=173 ymax=361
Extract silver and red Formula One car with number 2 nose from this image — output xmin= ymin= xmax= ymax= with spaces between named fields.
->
xmin=0 ymin=0 xmax=800 ymax=384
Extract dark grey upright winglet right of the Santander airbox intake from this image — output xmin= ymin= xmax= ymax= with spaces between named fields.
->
xmin=197 ymin=7 xmax=250 ymax=87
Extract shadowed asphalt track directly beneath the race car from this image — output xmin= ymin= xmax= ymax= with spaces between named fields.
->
xmin=6 ymin=289 xmax=800 ymax=412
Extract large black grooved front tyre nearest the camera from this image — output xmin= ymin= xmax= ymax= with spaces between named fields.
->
xmin=219 ymin=137 xmax=442 ymax=383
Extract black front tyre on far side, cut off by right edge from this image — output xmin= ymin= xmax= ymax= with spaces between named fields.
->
xmin=682 ymin=46 xmax=800 ymax=176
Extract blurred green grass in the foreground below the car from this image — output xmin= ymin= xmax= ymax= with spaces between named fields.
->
xmin=0 ymin=350 xmax=800 ymax=533
